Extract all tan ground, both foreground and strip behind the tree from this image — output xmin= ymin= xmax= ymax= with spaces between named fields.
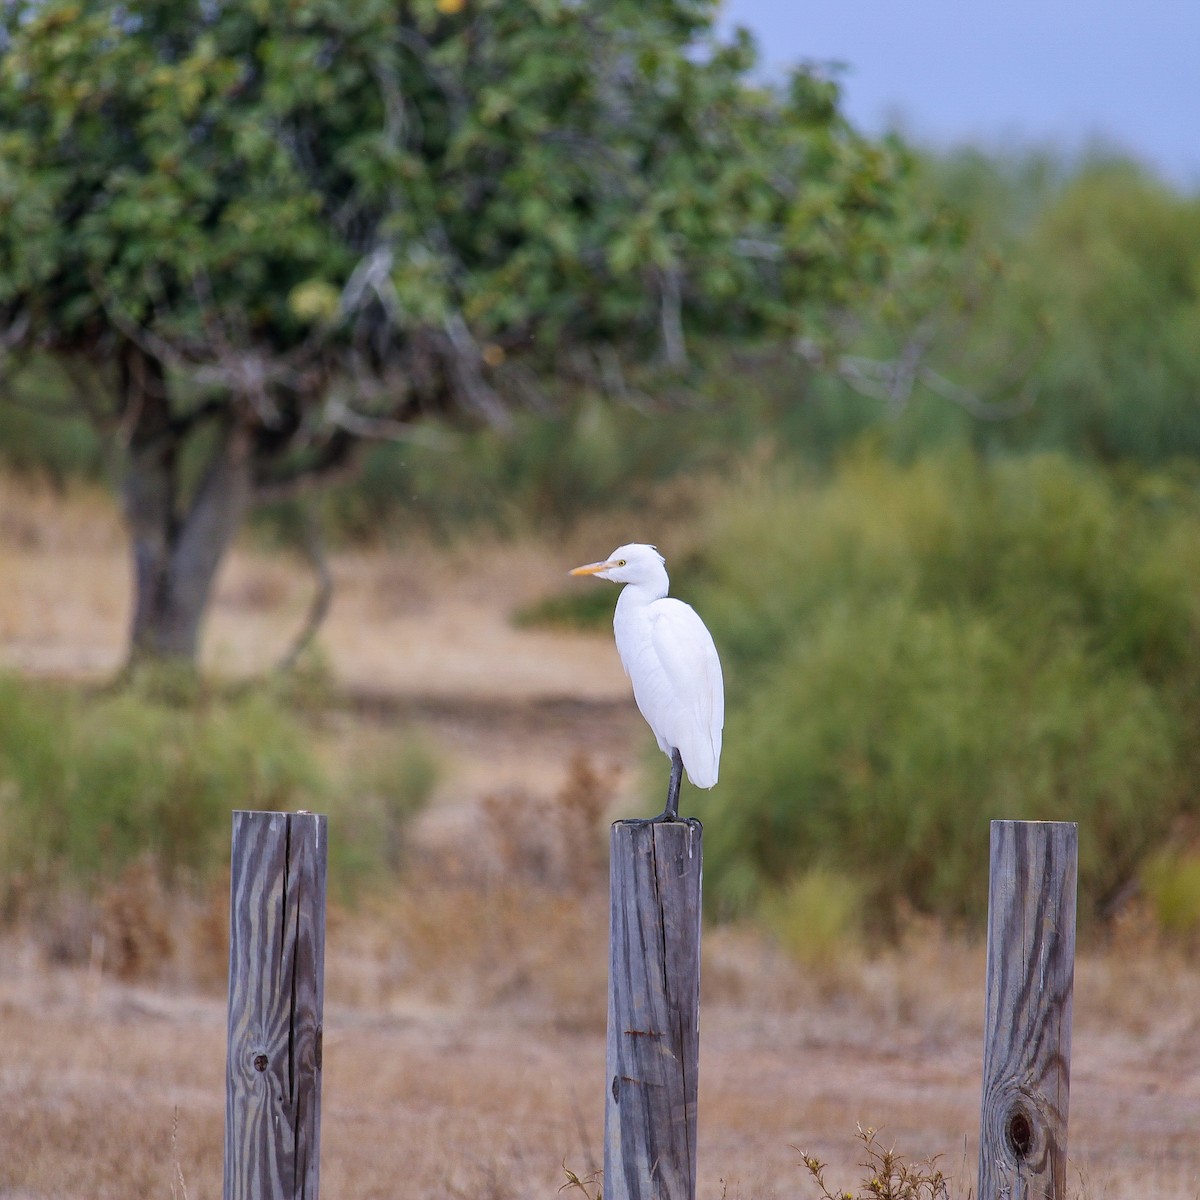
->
xmin=0 ymin=481 xmax=1200 ymax=1200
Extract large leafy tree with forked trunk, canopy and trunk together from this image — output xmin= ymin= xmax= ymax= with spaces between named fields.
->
xmin=0 ymin=0 xmax=902 ymax=661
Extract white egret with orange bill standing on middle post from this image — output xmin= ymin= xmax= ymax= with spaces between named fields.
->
xmin=571 ymin=542 xmax=725 ymax=821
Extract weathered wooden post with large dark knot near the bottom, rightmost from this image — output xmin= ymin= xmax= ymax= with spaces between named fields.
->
xmin=978 ymin=821 xmax=1079 ymax=1200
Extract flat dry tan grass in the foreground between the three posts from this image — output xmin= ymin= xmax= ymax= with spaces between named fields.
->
xmin=7 ymin=912 xmax=1200 ymax=1200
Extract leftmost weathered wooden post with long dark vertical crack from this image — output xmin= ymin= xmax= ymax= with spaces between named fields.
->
xmin=224 ymin=811 xmax=326 ymax=1200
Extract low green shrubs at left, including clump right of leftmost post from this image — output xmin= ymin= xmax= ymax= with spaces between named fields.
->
xmin=0 ymin=674 xmax=438 ymax=895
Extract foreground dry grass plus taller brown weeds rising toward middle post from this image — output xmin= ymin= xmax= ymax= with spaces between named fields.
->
xmin=7 ymin=758 xmax=1200 ymax=1200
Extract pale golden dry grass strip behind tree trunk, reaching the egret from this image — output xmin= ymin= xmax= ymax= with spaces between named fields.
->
xmin=0 ymin=476 xmax=625 ymax=702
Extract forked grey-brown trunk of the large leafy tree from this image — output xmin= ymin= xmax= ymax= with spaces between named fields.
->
xmin=121 ymin=352 xmax=252 ymax=666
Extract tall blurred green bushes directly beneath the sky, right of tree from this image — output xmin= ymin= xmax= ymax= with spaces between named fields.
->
xmin=726 ymin=152 xmax=1200 ymax=477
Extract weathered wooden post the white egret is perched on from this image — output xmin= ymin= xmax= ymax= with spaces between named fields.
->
xmin=604 ymin=820 xmax=702 ymax=1200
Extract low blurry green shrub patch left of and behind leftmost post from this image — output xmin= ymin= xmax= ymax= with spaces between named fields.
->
xmin=0 ymin=679 xmax=325 ymax=881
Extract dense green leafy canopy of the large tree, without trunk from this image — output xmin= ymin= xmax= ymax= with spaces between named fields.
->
xmin=0 ymin=0 xmax=905 ymax=374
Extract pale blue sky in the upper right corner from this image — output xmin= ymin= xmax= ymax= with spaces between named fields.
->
xmin=721 ymin=0 xmax=1200 ymax=191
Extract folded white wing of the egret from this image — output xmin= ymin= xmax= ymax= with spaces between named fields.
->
xmin=650 ymin=599 xmax=725 ymax=787
